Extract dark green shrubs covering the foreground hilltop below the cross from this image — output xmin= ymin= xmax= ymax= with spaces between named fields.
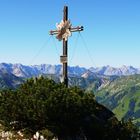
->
xmin=0 ymin=77 xmax=139 ymax=140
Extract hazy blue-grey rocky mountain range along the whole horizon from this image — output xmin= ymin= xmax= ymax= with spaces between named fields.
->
xmin=0 ymin=63 xmax=140 ymax=78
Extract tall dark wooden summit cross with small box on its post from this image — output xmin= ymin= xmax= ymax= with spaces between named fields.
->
xmin=50 ymin=6 xmax=84 ymax=87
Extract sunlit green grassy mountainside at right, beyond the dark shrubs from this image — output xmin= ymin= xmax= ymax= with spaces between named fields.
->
xmin=96 ymin=75 xmax=140 ymax=125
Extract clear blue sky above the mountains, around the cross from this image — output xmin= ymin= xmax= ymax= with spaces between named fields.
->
xmin=0 ymin=0 xmax=140 ymax=67
